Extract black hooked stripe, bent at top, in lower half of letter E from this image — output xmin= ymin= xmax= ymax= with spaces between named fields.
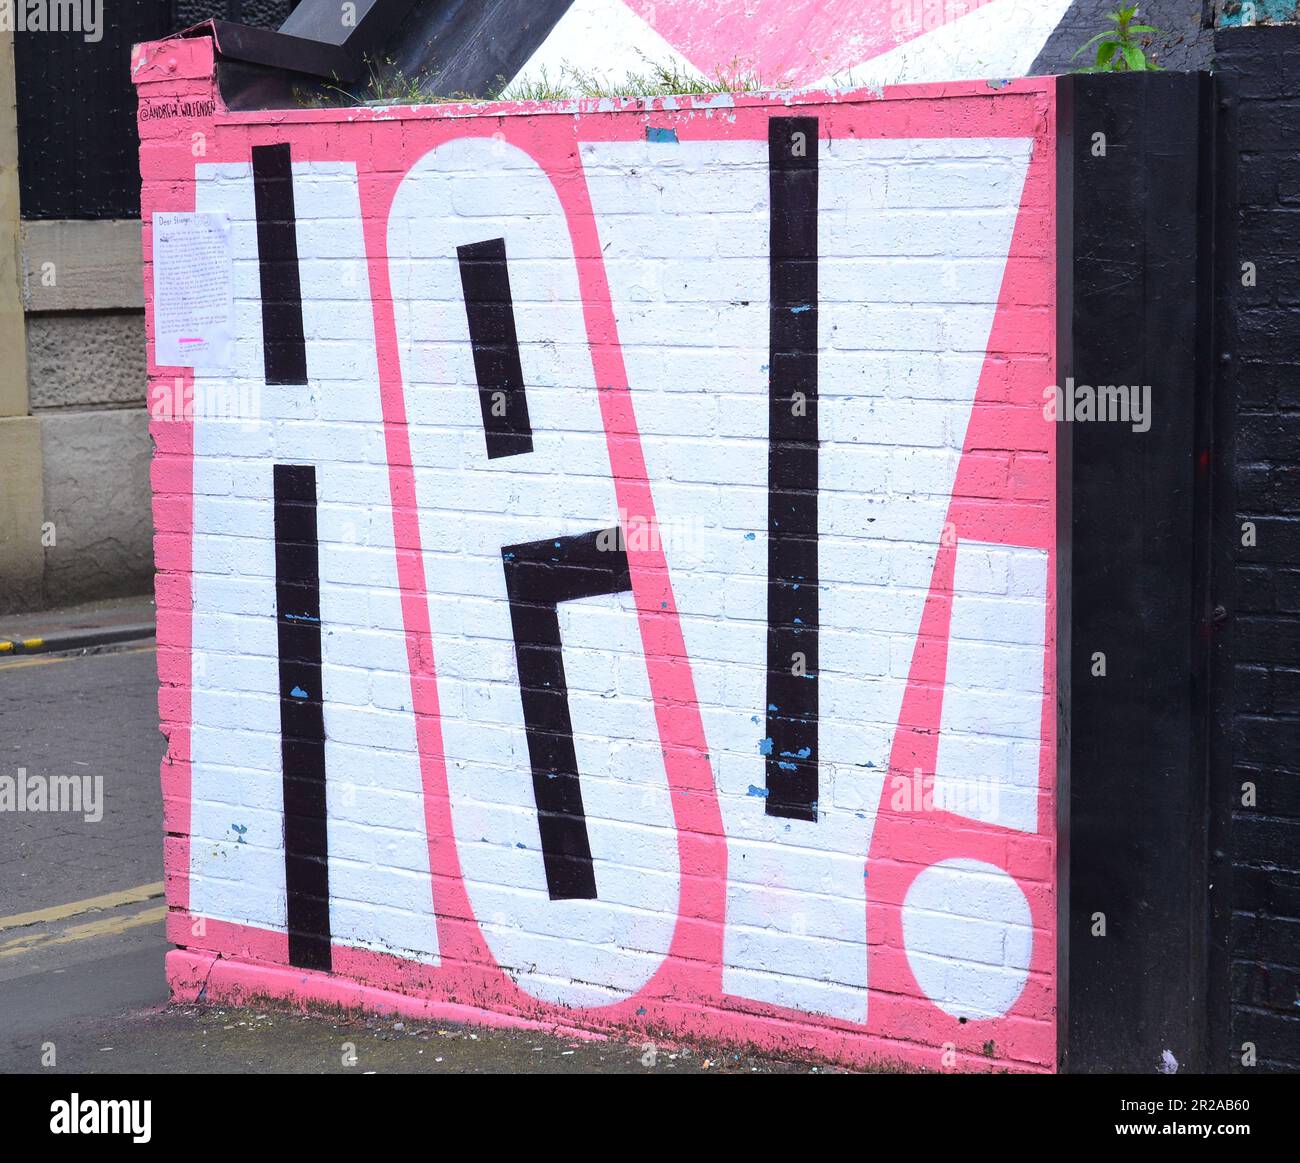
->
xmin=501 ymin=529 xmax=632 ymax=901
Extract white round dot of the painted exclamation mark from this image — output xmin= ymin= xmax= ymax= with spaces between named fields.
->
xmin=902 ymin=860 xmax=1034 ymax=1019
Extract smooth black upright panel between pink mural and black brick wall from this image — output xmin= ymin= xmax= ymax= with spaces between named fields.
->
xmin=1058 ymin=73 xmax=1212 ymax=1073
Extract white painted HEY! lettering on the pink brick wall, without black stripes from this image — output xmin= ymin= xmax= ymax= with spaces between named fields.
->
xmin=146 ymin=65 xmax=1053 ymax=1064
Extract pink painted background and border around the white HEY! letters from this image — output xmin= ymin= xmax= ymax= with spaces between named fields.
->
xmin=133 ymin=38 xmax=1057 ymax=1069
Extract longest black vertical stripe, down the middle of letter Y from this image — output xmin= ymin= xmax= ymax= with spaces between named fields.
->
xmin=764 ymin=117 xmax=818 ymax=820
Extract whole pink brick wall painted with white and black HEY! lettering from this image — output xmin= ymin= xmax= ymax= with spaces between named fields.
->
xmin=134 ymin=38 xmax=1057 ymax=1071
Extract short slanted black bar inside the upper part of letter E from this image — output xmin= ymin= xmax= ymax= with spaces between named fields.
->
xmin=456 ymin=238 xmax=533 ymax=460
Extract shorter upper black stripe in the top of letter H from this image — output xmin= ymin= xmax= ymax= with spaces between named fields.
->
xmin=252 ymin=143 xmax=307 ymax=383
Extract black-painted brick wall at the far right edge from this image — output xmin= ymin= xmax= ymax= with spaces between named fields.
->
xmin=1210 ymin=27 xmax=1300 ymax=1071
